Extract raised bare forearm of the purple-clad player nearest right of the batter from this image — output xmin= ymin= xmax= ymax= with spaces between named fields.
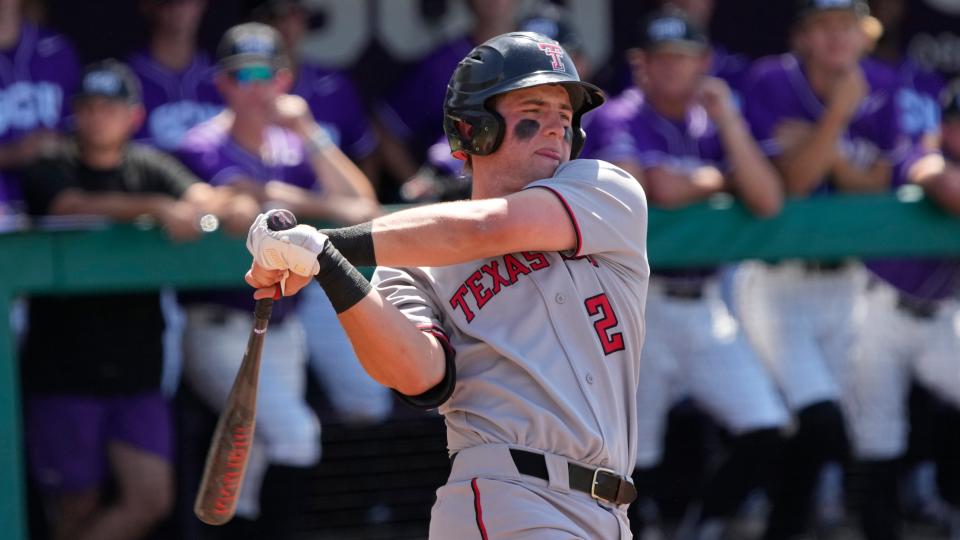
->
xmin=720 ymin=116 xmax=783 ymax=217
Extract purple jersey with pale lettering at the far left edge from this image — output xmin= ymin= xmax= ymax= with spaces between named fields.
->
xmin=0 ymin=22 xmax=80 ymax=201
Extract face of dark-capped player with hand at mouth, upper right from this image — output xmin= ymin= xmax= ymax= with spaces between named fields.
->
xmin=797 ymin=10 xmax=866 ymax=71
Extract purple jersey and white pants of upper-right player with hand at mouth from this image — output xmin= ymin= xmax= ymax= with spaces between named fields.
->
xmin=735 ymin=54 xmax=915 ymax=411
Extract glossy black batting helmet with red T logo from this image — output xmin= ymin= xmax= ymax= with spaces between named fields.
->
xmin=443 ymin=32 xmax=606 ymax=160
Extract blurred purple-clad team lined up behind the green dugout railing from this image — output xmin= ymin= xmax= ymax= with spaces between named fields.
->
xmin=0 ymin=0 xmax=960 ymax=540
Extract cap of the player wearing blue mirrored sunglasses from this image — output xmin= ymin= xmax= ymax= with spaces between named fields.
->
xmin=217 ymin=22 xmax=288 ymax=71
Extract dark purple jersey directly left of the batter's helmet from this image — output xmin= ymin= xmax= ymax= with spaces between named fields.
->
xmin=378 ymin=37 xmax=474 ymax=153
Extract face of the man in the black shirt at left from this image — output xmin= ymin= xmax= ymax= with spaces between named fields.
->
xmin=73 ymin=97 xmax=143 ymax=148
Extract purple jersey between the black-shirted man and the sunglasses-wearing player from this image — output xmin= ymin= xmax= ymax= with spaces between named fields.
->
xmin=129 ymin=51 xmax=223 ymax=152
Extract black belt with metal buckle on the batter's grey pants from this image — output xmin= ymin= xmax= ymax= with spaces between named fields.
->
xmin=450 ymin=448 xmax=637 ymax=504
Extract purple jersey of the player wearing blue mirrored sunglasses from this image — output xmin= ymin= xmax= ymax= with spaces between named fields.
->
xmin=176 ymin=118 xmax=321 ymax=314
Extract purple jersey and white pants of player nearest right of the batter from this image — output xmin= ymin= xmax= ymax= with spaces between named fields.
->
xmin=587 ymin=88 xmax=787 ymax=468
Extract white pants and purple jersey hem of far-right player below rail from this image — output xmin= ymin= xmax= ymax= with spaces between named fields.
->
xmin=845 ymin=178 xmax=960 ymax=460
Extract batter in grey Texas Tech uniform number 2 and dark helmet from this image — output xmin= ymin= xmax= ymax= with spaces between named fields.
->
xmin=247 ymin=32 xmax=649 ymax=539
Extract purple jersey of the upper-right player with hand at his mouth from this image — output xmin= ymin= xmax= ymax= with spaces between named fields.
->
xmin=742 ymin=53 xmax=911 ymax=194
